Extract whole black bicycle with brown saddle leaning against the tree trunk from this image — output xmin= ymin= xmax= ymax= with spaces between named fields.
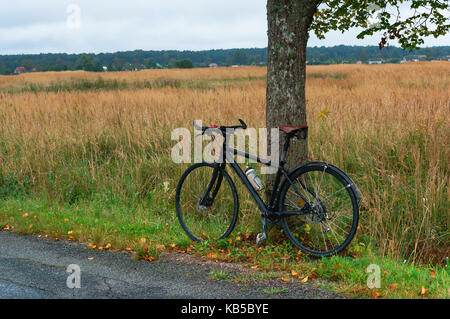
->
xmin=175 ymin=119 xmax=360 ymax=257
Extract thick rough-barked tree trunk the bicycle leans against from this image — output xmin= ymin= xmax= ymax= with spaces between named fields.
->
xmin=266 ymin=0 xmax=320 ymax=199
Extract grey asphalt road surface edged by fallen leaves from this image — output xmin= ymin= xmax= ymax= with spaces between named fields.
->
xmin=0 ymin=231 xmax=339 ymax=299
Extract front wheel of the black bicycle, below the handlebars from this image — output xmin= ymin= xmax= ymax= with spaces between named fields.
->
xmin=175 ymin=163 xmax=239 ymax=242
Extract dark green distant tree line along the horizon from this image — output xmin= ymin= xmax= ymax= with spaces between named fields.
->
xmin=0 ymin=45 xmax=450 ymax=74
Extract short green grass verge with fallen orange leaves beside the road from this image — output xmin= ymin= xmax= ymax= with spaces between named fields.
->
xmin=0 ymin=197 xmax=450 ymax=298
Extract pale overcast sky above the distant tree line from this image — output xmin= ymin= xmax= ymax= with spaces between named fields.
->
xmin=0 ymin=0 xmax=450 ymax=54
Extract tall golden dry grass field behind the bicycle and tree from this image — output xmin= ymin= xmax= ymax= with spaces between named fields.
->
xmin=0 ymin=62 xmax=450 ymax=298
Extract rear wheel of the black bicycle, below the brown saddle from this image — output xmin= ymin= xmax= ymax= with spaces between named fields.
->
xmin=279 ymin=163 xmax=359 ymax=257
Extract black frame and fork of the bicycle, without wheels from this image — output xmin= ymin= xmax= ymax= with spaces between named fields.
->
xmin=200 ymin=129 xmax=315 ymax=217
